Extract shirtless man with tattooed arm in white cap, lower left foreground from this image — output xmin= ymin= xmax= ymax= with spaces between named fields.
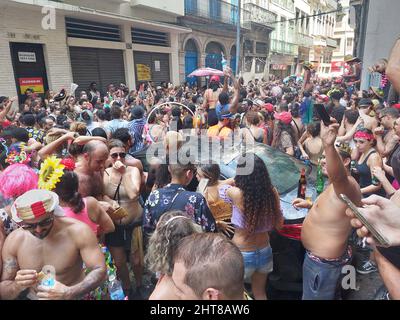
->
xmin=0 ymin=190 xmax=106 ymax=300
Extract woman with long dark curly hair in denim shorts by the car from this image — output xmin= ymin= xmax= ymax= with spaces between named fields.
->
xmin=220 ymin=154 xmax=283 ymax=300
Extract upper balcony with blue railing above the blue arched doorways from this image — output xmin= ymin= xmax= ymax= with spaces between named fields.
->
xmin=185 ymin=0 xmax=250 ymax=27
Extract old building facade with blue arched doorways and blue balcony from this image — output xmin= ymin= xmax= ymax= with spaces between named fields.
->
xmin=179 ymin=0 xmax=244 ymax=84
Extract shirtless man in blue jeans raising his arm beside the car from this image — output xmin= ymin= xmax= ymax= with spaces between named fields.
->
xmin=301 ymin=118 xmax=361 ymax=300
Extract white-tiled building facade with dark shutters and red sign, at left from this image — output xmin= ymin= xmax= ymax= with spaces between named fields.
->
xmin=0 ymin=0 xmax=191 ymax=100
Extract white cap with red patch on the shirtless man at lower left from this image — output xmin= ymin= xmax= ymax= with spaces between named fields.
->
xmin=11 ymin=189 xmax=65 ymax=223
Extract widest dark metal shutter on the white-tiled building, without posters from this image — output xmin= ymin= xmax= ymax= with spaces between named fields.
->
xmin=69 ymin=47 xmax=125 ymax=93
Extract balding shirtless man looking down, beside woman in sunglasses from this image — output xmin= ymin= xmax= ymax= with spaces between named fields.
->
xmin=75 ymin=141 xmax=109 ymax=201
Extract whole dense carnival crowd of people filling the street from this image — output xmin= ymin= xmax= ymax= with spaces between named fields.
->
xmin=0 ymin=37 xmax=400 ymax=300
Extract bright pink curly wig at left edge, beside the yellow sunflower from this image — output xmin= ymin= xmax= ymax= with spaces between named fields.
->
xmin=0 ymin=163 xmax=39 ymax=199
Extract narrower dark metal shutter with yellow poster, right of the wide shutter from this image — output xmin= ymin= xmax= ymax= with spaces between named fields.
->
xmin=134 ymin=51 xmax=170 ymax=85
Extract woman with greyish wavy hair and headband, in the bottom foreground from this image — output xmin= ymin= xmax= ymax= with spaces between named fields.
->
xmin=145 ymin=210 xmax=202 ymax=300
